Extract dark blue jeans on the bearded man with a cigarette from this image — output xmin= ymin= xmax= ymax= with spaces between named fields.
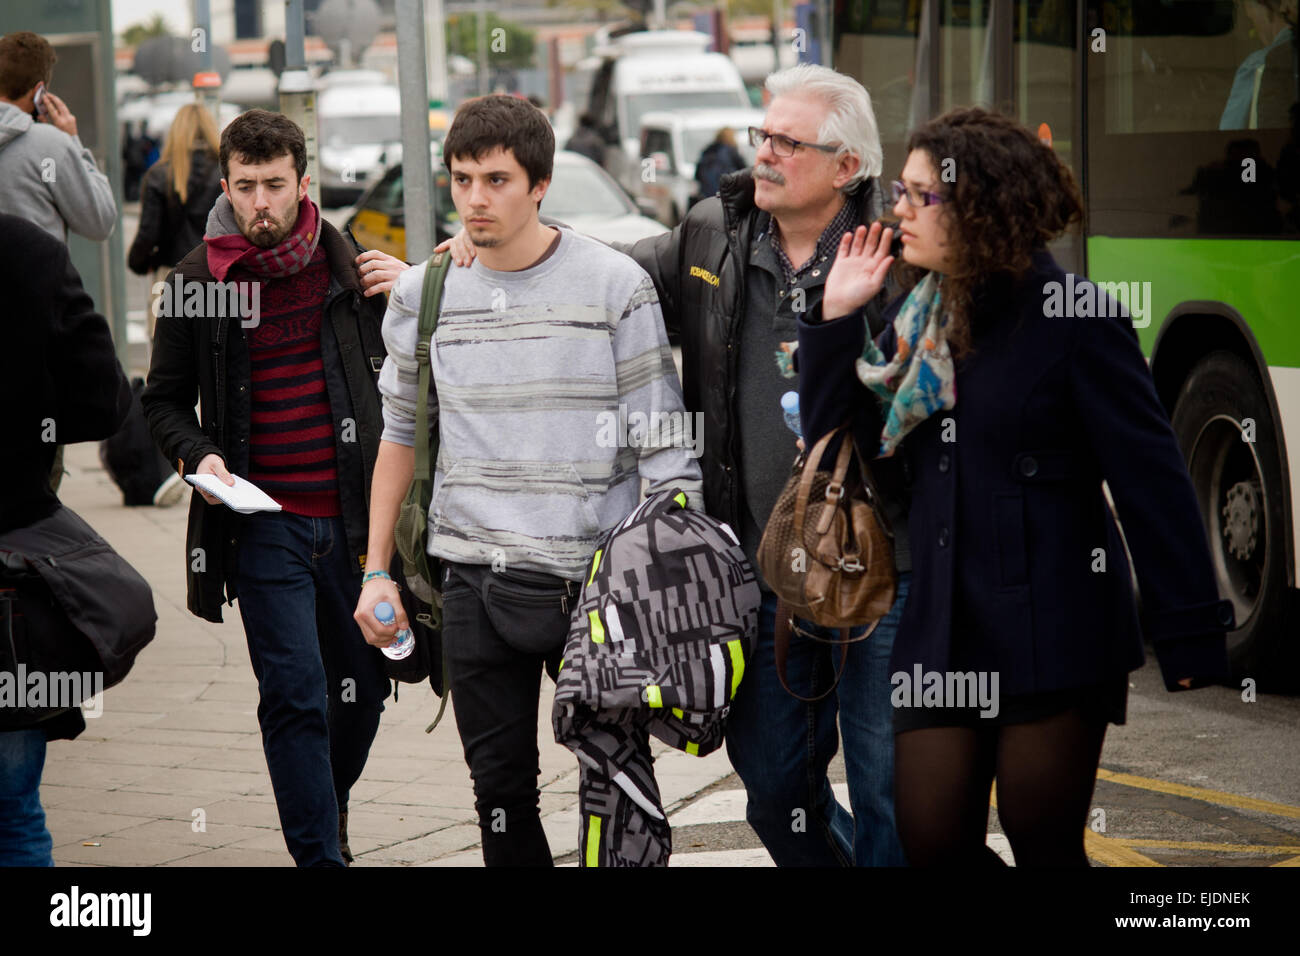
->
xmin=235 ymin=511 xmax=389 ymax=866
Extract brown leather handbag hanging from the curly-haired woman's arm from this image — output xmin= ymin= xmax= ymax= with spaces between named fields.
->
xmin=758 ymin=423 xmax=898 ymax=700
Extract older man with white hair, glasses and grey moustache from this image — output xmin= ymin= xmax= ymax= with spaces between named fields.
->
xmin=620 ymin=65 xmax=911 ymax=866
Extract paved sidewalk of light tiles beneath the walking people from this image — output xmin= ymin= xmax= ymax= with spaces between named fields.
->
xmin=40 ymin=444 xmax=732 ymax=866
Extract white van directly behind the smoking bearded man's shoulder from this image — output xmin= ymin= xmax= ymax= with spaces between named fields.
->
xmin=316 ymin=77 xmax=402 ymax=207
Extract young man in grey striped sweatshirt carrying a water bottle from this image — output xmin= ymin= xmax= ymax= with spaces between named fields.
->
xmin=355 ymin=96 xmax=702 ymax=866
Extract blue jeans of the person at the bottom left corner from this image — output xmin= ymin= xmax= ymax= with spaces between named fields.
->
xmin=0 ymin=730 xmax=55 ymax=866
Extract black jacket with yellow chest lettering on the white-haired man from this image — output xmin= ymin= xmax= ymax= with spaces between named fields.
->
xmin=614 ymin=170 xmax=902 ymax=538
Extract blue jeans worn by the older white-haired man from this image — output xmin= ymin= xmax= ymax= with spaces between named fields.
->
xmin=727 ymin=572 xmax=911 ymax=866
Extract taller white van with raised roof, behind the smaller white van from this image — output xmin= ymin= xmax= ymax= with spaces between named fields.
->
xmin=588 ymin=30 xmax=750 ymax=195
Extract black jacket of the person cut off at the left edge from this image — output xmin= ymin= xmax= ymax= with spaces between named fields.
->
xmin=0 ymin=215 xmax=131 ymax=532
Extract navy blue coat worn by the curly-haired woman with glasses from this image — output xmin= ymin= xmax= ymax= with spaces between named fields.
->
xmin=798 ymin=250 xmax=1232 ymax=695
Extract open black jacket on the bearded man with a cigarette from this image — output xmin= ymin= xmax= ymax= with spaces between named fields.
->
xmin=140 ymin=219 xmax=386 ymax=620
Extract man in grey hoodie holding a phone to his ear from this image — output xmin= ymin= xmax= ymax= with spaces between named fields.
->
xmin=0 ymin=30 xmax=117 ymax=242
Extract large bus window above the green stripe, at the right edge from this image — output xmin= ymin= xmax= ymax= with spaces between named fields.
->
xmin=1081 ymin=0 xmax=1300 ymax=238
